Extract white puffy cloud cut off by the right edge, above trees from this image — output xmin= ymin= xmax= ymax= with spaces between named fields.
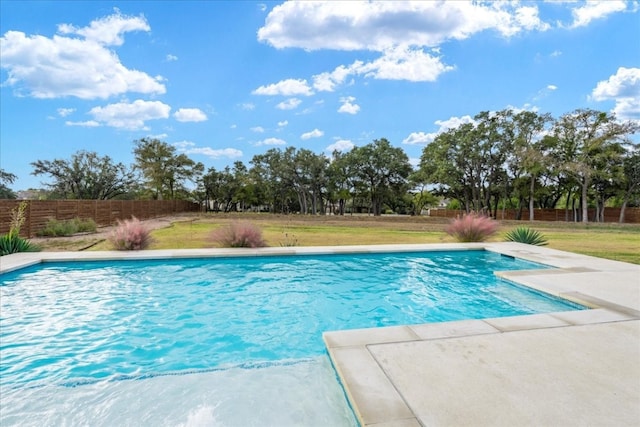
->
xmin=591 ymin=67 xmax=640 ymax=120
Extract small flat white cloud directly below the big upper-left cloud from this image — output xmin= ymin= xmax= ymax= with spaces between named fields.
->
xmin=89 ymin=99 xmax=171 ymax=130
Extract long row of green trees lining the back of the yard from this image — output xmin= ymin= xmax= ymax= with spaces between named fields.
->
xmin=18 ymin=109 xmax=640 ymax=221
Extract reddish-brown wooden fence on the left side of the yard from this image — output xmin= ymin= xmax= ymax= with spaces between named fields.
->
xmin=0 ymin=200 xmax=200 ymax=237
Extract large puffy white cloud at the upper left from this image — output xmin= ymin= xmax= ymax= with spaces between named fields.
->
xmin=0 ymin=13 xmax=166 ymax=99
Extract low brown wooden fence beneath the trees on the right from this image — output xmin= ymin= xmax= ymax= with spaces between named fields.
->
xmin=429 ymin=208 xmax=640 ymax=224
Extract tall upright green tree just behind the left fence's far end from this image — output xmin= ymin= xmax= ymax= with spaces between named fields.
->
xmin=133 ymin=138 xmax=204 ymax=200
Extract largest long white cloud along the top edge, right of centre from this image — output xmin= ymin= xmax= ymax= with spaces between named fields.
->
xmin=258 ymin=1 xmax=549 ymax=52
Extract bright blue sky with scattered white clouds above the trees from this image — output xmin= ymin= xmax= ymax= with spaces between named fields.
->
xmin=0 ymin=0 xmax=640 ymax=190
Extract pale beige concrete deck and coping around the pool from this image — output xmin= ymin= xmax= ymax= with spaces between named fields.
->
xmin=0 ymin=243 xmax=640 ymax=427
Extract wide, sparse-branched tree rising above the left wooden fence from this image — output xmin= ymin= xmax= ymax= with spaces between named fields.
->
xmin=31 ymin=151 xmax=135 ymax=200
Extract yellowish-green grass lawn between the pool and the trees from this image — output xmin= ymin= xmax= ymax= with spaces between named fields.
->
xmin=84 ymin=214 xmax=640 ymax=264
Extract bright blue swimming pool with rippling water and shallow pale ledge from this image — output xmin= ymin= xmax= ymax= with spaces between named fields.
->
xmin=0 ymin=251 xmax=578 ymax=425
